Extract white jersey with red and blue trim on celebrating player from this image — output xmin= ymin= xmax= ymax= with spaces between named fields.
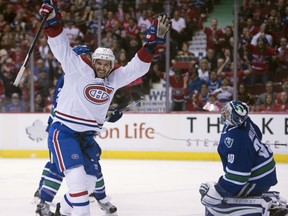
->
xmin=48 ymin=31 xmax=151 ymax=132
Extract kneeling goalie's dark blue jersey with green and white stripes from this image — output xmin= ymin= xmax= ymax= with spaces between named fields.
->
xmin=216 ymin=117 xmax=277 ymax=196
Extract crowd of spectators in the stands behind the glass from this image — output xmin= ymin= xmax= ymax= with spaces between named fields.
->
xmin=0 ymin=0 xmax=288 ymax=112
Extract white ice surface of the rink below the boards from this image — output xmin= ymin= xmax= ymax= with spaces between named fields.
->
xmin=0 ymin=158 xmax=288 ymax=216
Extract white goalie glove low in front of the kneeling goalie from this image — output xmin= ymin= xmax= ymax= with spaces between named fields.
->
xmin=199 ymin=182 xmax=223 ymax=207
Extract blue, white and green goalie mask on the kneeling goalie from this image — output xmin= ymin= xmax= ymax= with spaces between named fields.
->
xmin=220 ymin=101 xmax=249 ymax=126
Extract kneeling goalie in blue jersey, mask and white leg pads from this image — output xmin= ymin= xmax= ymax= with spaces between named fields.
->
xmin=199 ymin=101 xmax=287 ymax=216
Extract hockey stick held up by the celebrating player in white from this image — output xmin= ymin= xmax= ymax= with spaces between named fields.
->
xmin=13 ymin=15 xmax=48 ymax=86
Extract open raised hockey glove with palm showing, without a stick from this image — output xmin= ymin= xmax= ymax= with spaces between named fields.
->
xmin=145 ymin=14 xmax=171 ymax=53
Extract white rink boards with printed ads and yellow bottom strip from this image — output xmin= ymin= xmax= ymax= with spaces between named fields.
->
xmin=0 ymin=113 xmax=288 ymax=163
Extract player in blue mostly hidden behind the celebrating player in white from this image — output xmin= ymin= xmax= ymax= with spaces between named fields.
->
xmin=34 ymin=51 xmax=123 ymax=216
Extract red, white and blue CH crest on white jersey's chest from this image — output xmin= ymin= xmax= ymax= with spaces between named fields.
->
xmin=84 ymin=85 xmax=113 ymax=104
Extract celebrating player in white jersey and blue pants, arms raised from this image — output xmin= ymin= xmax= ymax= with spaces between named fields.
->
xmin=39 ymin=0 xmax=171 ymax=216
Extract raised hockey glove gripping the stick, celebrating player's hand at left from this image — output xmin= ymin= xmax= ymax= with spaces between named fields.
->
xmin=39 ymin=0 xmax=62 ymax=28
